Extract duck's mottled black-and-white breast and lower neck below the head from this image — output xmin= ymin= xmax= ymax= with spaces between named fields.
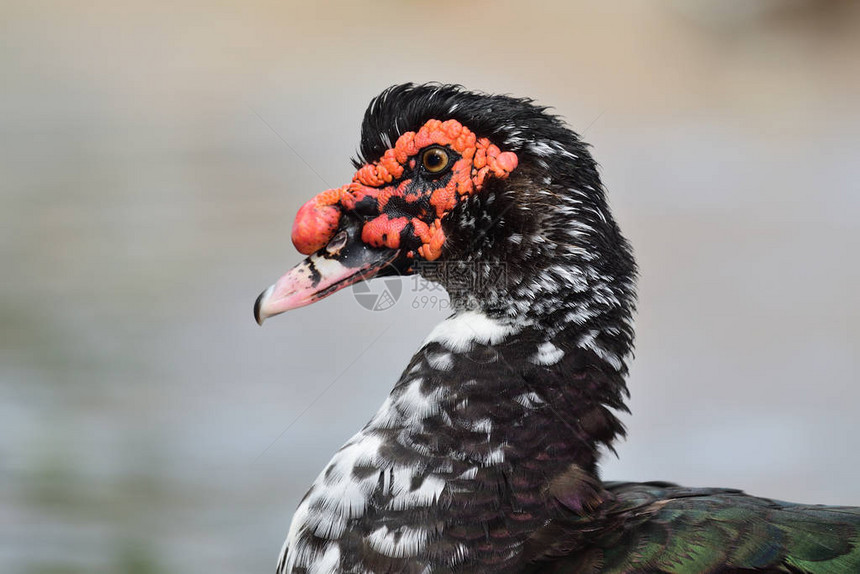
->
xmin=280 ymin=312 xmax=621 ymax=572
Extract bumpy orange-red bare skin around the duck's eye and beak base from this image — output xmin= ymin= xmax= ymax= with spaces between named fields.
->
xmin=293 ymin=120 xmax=518 ymax=261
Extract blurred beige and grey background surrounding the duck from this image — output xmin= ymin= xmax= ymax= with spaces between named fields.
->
xmin=0 ymin=0 xmax=860 ymax=574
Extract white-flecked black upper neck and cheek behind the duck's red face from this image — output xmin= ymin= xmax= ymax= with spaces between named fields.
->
xmin=426 ymin=166 xmax=636 ymax=375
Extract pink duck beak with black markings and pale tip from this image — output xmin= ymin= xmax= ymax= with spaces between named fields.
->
xmin=254 ymin=218 xmax=400 ymax=325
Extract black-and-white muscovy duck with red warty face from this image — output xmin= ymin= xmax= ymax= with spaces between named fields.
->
xmin=254 ymin=84 xmax=860 ymax=574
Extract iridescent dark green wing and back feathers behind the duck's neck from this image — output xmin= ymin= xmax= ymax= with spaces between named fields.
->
xmin=591 ymin=483 xmax=860 ymax=574
